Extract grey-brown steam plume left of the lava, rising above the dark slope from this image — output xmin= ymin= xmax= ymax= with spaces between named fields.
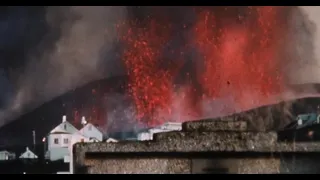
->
xmin=0 ymin=6 xmax=126 ymax=126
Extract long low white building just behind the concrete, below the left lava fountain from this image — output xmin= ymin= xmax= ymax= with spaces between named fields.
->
xmin=138 ymin=122 xmax=182 ymax=141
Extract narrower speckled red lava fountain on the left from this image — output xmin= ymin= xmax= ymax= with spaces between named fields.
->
xmin=124 ymin=20 xmax=179 ymax=124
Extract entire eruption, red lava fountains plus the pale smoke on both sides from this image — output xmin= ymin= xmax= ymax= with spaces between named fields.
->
xmin=0 ymin=6 xmax=319 ymax=134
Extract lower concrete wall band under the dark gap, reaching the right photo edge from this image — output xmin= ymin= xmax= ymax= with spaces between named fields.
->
xmin=77 ymin=153 xmax=320 ymax=174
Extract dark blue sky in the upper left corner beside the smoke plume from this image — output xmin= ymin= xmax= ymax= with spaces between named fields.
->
xmin=0 ymin=6 xmax=45 ymax=108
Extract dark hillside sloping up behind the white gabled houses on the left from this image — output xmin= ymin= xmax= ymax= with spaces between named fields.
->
xmin=0 ymin=74 xmax=125 ymax=146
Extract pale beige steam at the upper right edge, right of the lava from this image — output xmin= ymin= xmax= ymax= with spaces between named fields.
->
xmin=288 ymin=6 xmax=320 ymax=84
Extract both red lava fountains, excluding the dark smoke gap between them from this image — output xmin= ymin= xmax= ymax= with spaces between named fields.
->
xmin=123 ymin=7 xmax=292 ymax=124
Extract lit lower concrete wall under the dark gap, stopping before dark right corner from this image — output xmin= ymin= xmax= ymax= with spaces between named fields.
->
xmin=80 ymin=157 xmax=281 ymax=174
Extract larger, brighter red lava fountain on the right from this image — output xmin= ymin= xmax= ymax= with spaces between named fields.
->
xmin=195 ymin=7 xmax=285 ymax=109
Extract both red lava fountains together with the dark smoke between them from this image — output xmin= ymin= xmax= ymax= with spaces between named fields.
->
xmin=112 ymin=6 xmax=318 ymax=125
